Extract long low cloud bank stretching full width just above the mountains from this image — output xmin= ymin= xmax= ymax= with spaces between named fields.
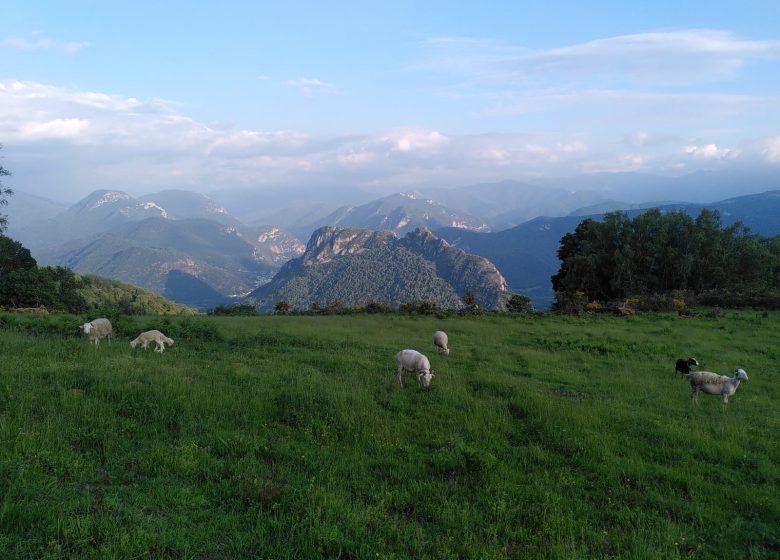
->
xmin=0 ymin=81 xmax=780 ymax=200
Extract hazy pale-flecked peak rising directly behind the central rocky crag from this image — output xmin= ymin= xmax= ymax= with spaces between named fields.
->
xmin=296 ymin=193 xmax=490 ymax=241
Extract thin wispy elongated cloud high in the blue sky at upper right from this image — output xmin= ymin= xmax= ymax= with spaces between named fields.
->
xmin=424 ymin=29 xmax=780 ymax=87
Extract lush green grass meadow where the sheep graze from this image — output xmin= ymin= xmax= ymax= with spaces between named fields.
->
xmin=0 ymin=311 xmax=780 ymax=560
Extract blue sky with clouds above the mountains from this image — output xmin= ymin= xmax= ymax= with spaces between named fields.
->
xmin=0 ymin=0 xmax=780 ymax=202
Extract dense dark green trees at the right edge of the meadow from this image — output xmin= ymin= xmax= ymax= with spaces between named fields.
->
xmin=552 ymin=209 xmax=780 ymax=301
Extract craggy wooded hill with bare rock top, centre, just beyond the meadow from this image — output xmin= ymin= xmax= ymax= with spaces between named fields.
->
xmin=248 ymin=227 xmax=508 ymax=311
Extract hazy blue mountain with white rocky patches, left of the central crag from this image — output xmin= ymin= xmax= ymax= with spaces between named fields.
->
xmin=14 ymin=190 xmax=305 ymax=309
